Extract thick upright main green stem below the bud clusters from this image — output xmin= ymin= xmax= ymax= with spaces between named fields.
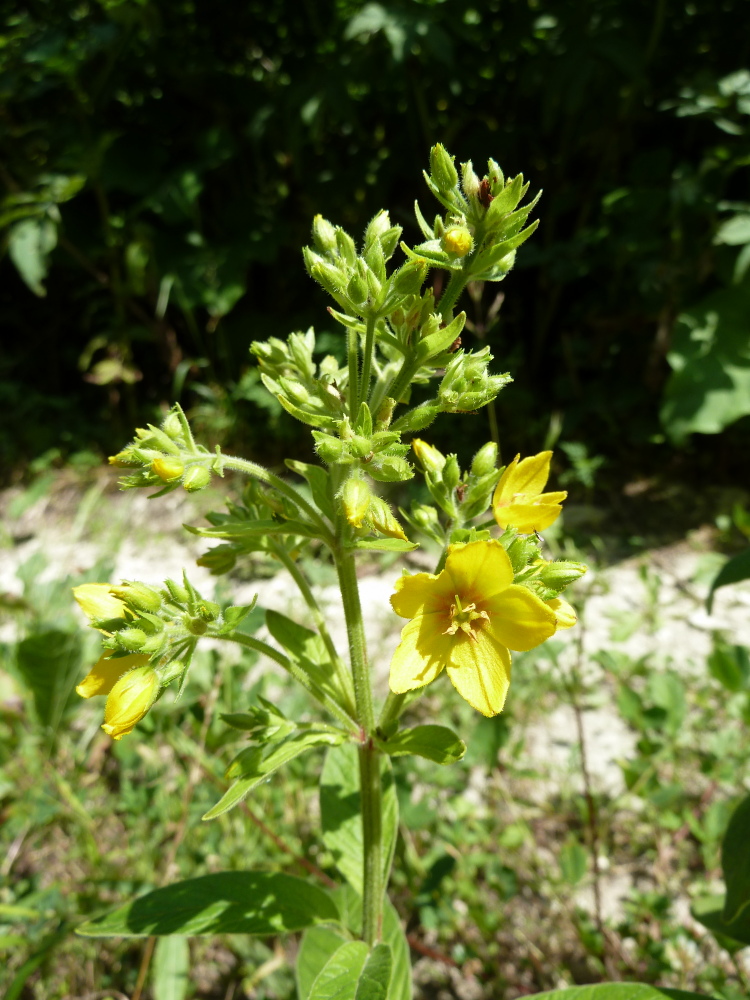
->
xmin=335 ymin=548 xmax=384 ymax=945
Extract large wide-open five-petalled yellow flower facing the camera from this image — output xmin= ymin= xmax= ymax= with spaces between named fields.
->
xmin=390 ymin=541 xmax=556 ymax=716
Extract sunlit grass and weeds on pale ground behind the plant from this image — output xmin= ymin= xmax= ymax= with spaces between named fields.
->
xmin=0 ymin=470 xmax=750 ymax=1000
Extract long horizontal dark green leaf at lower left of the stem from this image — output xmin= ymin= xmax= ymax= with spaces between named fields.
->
xmin=76 ymin=872 xmax=338 ymax=937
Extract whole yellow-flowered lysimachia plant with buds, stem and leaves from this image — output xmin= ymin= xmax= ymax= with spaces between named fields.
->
xmin=76 ymin=145 xmax=704 ymax=1000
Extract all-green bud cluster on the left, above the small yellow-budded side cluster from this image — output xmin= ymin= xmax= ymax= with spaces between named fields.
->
xmin=250 ymin=328 xmax=348 ymax=428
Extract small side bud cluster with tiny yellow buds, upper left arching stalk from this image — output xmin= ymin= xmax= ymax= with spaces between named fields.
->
xmin=109 ymin=404 xmax=221 ymax=497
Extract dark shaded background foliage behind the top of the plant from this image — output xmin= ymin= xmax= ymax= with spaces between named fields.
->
xmin=0 ymin=0 xmax=750 ymax=474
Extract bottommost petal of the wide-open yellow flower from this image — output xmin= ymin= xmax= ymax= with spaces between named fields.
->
xmin=447 ymin=627 xmax=510 ymax=716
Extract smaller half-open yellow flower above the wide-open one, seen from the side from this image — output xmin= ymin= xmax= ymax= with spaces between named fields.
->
xmin=492 ymin=451 xmax=568 ymax=535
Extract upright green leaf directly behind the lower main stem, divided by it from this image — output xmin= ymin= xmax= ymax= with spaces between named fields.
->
xmin=320 ymin=743 xmax=398 ymax=896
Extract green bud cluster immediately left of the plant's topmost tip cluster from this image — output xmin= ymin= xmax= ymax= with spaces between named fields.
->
xmin=302 ymin=212 xmax=428 ymax=319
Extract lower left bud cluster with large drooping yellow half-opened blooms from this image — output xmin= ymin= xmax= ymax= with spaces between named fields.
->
xmin=73 ymin=576 xmax=252 ymax=740
